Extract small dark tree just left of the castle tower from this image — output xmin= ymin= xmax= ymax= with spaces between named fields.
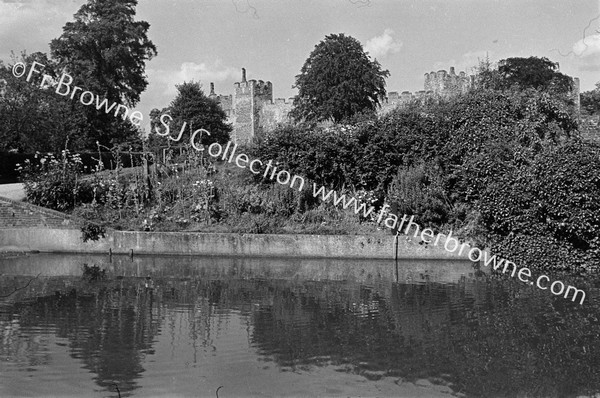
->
xmin=151 ymin=82 xmax=232 ymax=145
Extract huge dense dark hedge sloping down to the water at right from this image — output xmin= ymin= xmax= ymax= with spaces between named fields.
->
xmin=253 ymin=90 xmax=600 ymax=270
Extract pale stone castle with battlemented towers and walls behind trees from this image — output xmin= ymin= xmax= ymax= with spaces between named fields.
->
xmin=209 ymin=67 xmax=579 ymax=143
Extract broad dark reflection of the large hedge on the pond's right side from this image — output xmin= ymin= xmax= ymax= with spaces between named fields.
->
xmin=245 ymin=282 xmax=600 ymax=397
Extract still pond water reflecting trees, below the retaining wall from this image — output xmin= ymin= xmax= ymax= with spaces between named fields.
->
xmin=0 ymin=254 xmax=600 ymax=398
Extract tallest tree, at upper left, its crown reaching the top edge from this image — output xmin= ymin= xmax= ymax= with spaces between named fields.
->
xmin=50 ymin=0 xmax=157 ymax=146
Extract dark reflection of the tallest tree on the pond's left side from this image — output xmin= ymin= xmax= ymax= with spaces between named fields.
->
xmin=5 ymin=285 xmax=163 ymax=396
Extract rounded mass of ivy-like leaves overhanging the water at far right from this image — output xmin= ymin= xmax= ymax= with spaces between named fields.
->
xmin=478 ymin=140 xmax=600 ymax=269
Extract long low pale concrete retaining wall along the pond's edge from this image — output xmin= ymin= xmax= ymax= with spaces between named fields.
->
xmin=0 ymin=228 xmax=467 ymax=259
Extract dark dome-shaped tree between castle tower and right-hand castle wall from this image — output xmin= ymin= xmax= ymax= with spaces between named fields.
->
xmin=291 ymin=33 xmax=390 ymax=122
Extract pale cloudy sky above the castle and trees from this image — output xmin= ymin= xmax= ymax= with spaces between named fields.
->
xmin=0 ymin=0 xmax=600 ymax=130
